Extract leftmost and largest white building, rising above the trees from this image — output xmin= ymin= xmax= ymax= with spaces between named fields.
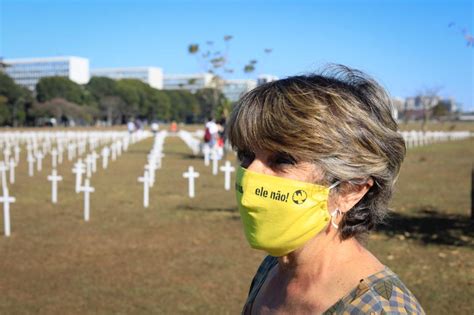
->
xmin=3 ymin=56 xmax=89 ymax=90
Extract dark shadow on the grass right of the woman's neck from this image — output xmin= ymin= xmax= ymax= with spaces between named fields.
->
xmin=377 ymin=207 xmax=474 ymax=248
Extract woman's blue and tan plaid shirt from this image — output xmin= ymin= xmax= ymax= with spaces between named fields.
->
xmin=242 ymin=256 xmax=425 ymax=315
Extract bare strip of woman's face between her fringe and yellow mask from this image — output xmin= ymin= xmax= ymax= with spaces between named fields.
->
xmin=238 ymin=150 xmax=336 ymax=209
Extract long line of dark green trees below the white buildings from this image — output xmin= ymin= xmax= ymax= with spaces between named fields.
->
xmin=0 ymin=72 xmax=231 ymax=126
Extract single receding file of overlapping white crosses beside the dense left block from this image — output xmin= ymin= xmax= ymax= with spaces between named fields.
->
xmin=138 ymin=130 xmax=168 ymax=208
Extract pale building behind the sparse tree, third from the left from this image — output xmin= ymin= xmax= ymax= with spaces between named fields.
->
xmin=163 ymin=73 xmax=215 ymax=93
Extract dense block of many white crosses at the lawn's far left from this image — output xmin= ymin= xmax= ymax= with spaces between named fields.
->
xmin=0 ymin=131 xmax=150 ymax=236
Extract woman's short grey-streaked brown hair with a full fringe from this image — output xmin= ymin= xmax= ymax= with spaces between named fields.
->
xmin=227 ymin=65 xmax=406 ymax=239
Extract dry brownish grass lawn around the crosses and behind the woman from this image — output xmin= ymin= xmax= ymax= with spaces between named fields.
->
xmin=0 ymin=130 xmax=474 ymax=314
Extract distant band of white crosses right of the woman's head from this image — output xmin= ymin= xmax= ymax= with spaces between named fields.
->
xmin=400 ymin=130 xmax=474 ymax=148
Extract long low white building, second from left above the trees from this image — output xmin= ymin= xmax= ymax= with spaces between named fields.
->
xmin=91 ymin=67 xmax=163 ymax=90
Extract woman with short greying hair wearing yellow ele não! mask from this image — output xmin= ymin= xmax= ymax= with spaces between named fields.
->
xmin=228 ymin=66 xmax=424 ymax=314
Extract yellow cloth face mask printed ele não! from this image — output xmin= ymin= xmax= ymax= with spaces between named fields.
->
xmin=235 ymin=167 xmax=337 ymax=256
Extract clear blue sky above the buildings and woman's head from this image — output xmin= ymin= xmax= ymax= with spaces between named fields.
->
xmin=0 ymin=0 xmax=474 ymax=110
